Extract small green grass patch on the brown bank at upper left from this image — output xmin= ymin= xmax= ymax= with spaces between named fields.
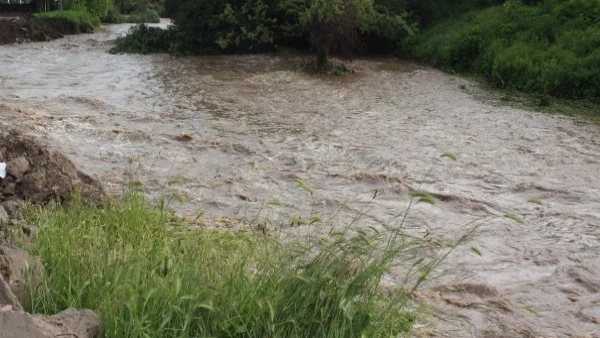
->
xmin=35 ymin=10 xmax=101 ymax=33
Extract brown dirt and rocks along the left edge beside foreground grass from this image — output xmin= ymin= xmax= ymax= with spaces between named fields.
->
xmin=0 ymin=126 xmax=104 ymax=338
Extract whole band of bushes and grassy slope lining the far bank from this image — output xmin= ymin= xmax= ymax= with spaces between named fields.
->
xmin=113 ymin=0 xmax=600 ymax=103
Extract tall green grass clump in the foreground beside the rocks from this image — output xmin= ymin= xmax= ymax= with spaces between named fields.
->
xmin=26 ymin=192 xmax=426 ymax=338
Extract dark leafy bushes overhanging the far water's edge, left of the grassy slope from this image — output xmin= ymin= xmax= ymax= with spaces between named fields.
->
xmin=118 ymin=0 xmax=416 ymax=62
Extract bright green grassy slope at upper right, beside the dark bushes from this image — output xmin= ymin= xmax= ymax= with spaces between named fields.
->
xmin=415 ymin=0 xmax=600 ymax=100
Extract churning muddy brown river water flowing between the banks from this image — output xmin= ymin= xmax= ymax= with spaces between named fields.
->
xmin=0 ymin=21 xmax=600 ymax=337
